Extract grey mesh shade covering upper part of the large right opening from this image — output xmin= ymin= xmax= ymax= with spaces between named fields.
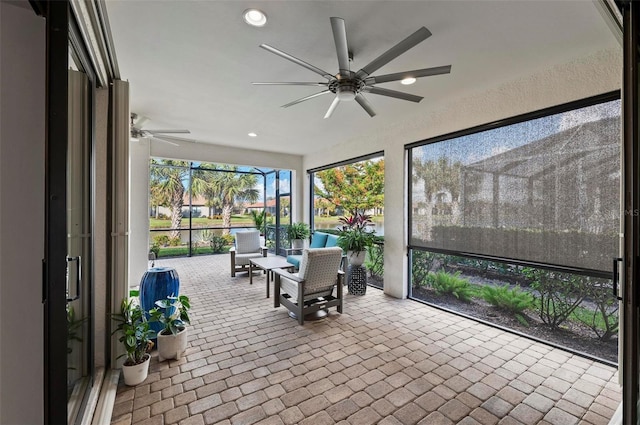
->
xmin=409 ymin=100 xmax=620 ymax=271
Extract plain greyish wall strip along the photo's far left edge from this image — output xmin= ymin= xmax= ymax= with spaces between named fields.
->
xmin=0 ymin=1 xmax=45 ymax=424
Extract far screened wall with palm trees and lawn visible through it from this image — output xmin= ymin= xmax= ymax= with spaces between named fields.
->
xmin=149 ymin=158 xmax=291 ymax=257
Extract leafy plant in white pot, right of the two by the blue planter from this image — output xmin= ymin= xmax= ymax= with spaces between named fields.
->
xmin=149 ymin=295 xmax=191 ymax=361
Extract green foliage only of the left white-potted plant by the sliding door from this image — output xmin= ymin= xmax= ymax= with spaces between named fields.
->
xmin=112 ymin=298 xmax=155 ymax=366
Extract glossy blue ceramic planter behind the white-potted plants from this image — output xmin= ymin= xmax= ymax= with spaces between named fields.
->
xmin=140 ymin=267 xmax=180 ymax=339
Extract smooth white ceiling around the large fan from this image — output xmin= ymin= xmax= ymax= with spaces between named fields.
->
xmin=107 ymin=0 xmax=619 ymax=155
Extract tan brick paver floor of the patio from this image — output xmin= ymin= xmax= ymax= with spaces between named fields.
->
xmin=112 ymin=255 xmax=620 ymax=425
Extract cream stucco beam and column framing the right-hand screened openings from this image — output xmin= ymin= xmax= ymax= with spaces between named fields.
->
xmin=302 ymin=48 xmax=622 ymax=298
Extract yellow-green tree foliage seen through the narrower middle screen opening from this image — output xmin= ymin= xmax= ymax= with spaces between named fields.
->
xmin=314 ymin=159 xmax=384 ymax=214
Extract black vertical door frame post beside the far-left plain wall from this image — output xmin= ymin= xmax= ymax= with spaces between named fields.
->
xmin=39 ymin=0 xmax=69 ymax=424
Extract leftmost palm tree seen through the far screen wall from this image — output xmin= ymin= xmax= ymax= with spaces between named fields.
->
xmin=150 ymin=159 xmax=189 ymax=239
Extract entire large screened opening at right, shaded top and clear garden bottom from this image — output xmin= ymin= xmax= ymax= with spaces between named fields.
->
xmin=407 ymin=93 xmax=621 ymax=364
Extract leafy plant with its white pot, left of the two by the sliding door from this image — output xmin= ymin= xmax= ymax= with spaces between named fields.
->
xmin=112 ymin=298 xmax=155 ymax=385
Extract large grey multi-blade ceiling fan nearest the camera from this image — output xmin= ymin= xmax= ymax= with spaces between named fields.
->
xmin=253 ymin=17 xmax=451 ymax=118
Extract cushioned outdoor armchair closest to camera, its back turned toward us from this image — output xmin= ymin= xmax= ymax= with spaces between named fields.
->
xmin=273 ymin=247 xmax=344 ymax=325
